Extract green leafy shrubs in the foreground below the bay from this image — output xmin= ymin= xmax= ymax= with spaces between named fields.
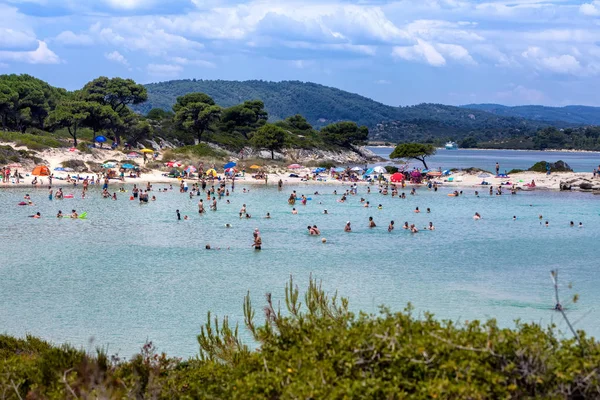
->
xmin=0 ymin=280 xmax=600 ymax=399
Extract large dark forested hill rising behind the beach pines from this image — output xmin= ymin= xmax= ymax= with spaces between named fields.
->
xmin=136 ymin=80 xmax=547 ymax=142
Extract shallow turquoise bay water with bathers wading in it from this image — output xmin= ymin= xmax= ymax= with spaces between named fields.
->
xmin=0 ymin=183 xmax=600 ymax=357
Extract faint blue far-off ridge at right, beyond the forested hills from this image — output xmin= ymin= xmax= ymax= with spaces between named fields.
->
xmin=461 ymin=104 xmax=600 ymax=125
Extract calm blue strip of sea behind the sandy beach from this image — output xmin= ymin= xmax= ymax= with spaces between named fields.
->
xmin=369 ymin=147 xmax=600 ymax=173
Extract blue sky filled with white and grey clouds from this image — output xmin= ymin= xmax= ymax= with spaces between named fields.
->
xmin=0 ymin=0 xmax=600 ymax=106
